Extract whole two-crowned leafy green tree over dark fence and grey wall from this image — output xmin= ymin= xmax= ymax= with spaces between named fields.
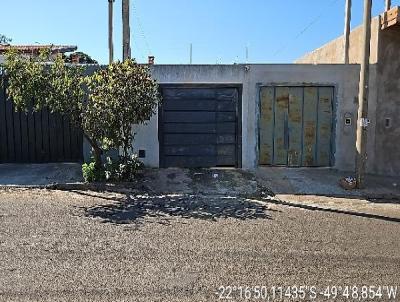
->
xmin=4 ymin=50 xmax=160 ymax=169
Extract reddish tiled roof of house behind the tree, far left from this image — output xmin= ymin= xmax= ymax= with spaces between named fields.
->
xmin=0 ymin=45 xmax=78 ymax=64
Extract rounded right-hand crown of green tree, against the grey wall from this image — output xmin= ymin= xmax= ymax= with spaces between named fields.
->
xmin=84 ymin=59 xmax=161 ymax=158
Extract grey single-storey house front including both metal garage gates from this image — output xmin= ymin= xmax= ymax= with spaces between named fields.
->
xmin=126 ymin=64 xmax=359 ymax=170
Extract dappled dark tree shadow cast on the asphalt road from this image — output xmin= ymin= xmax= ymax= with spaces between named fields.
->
xmin=84 ymin=194 xmax=272 ymax=224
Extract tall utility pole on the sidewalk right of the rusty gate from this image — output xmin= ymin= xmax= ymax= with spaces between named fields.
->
xmin=356 ymin=0 xmax=372 ymax=189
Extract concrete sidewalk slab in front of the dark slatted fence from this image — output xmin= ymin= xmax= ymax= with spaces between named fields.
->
xmin=0 ymin=163 xmax=83 ymax=187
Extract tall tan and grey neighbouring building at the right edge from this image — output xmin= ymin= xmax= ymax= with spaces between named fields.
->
xmin=296 ymin=7 xmax=400 ymax=175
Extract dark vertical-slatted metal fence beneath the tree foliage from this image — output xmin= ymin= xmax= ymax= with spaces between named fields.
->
xmin=0 ymin=79 xmax=83 ymax=163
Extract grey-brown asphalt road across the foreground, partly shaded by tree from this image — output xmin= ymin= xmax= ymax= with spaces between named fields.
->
xmin=0 ymin=190 xmax=400 ymax=301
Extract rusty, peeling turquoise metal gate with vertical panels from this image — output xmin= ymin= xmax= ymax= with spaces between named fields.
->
xmin=259 ymin=86 xmax=334 ymax=167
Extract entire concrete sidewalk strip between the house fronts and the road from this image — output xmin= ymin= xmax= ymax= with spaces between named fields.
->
xmin=0 ymin=163 xmax=400 ymax=221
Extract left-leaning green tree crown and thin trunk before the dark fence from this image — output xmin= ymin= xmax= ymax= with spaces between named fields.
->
xmin=4 ymin=49 xmax=102 ymax=167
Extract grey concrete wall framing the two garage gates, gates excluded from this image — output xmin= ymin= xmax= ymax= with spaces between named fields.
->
xmin=130 ymin=64 xmax=359 ymax=170
